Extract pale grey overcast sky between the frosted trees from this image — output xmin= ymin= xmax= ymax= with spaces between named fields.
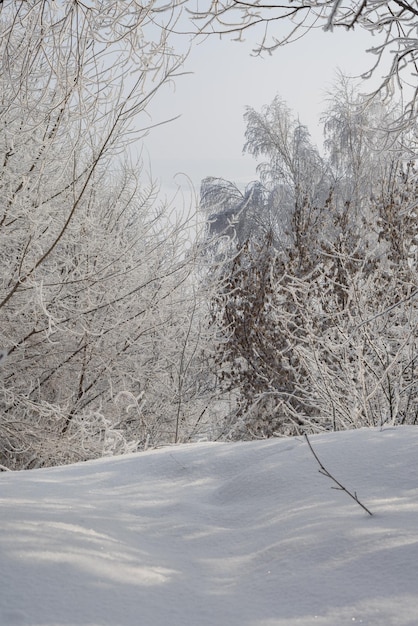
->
xmin=145 ymin=20 xmax=375 ymax=200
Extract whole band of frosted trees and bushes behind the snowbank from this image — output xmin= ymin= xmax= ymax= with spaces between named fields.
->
xmin=0 ymin=0 xmax=418 ymax=469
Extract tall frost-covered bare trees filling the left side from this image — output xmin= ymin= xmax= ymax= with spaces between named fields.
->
xmin=0 ymin=0 xmax=217 ymax=468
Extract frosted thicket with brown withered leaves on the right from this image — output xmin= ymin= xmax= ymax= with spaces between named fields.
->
xmin=203 ymin=85 xmax=418 ymax=437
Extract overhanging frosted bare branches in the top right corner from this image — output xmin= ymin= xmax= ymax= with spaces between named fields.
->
xmin=192 ymin=0 xmax=418 ymax=127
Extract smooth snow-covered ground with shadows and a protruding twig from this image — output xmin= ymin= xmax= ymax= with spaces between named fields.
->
xmin=0 ymin=427 xmax=418 ymax=626
